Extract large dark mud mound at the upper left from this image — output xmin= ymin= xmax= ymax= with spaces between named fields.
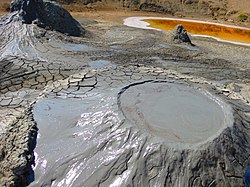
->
xmin=10 ymin=0 xmax=84 ymax=36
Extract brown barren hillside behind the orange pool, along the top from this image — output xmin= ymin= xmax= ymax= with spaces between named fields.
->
xmin=0 ymin=0 xmax=250 ymax=27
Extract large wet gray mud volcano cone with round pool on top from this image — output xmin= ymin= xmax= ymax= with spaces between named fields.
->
xmin=27 ymin=66 xmax=249 ymax=186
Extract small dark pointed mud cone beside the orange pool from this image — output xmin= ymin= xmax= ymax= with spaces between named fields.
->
xmin=173 ymin=24 xmax=194 ymax=46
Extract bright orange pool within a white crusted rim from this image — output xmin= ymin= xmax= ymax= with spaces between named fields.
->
xmin=144 ymin=19 xmax=250 ymax=44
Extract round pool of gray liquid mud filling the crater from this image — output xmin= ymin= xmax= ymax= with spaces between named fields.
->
xmin=119 ymin=82 xmax=233 ymax=144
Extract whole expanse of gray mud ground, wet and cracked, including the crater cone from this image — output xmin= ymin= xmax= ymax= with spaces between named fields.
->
xmin=0 ymin=4 xmax=250 ymax=187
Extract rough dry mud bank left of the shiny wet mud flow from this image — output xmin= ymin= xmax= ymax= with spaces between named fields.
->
xmin=0 ymin=110 xmax=37 ymax=186
